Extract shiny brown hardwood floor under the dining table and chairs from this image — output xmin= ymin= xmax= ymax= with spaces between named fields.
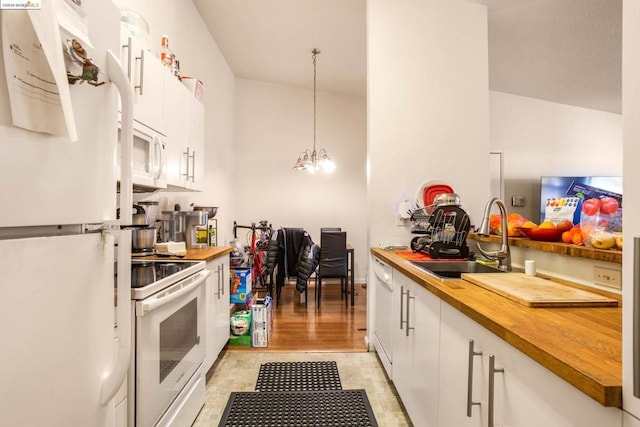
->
xmin=226 ymin=279 xmax=367 ymax=352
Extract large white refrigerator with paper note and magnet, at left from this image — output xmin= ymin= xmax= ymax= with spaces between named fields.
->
xmin=0 ymin=0 xmax=132 ymax=426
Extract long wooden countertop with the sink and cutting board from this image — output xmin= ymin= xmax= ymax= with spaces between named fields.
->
xmin=371 ymin=248 xmax=622 ymax=407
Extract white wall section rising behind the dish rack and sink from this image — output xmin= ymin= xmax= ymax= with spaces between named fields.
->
xmin=367 ymin=0 xmax=489 ymax=246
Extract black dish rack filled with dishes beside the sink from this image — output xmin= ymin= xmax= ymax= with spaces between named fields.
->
xmin=410 ymin=205 xmax=471 ymax=258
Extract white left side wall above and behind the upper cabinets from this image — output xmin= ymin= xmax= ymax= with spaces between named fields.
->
xmin=118 ymin=0 xmax=235 ymax=245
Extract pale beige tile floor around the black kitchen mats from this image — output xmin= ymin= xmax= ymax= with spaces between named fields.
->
xmin=193 ymin=352 xmax=412 ymax=427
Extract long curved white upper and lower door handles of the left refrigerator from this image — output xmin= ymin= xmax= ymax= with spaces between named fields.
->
xmin=100 ymin=50 xmax=133 ymax=406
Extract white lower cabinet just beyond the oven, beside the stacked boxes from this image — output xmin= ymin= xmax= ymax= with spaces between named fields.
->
xmin=204 ymin=256 xmax=230 ymax=372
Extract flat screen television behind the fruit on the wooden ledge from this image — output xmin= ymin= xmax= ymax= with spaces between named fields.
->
xmin=540 ymin=176 xmax=622 ymax=224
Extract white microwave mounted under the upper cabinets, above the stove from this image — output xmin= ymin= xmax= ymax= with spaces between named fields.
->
xmin=118 ymin=119 xmax=167 ymax=188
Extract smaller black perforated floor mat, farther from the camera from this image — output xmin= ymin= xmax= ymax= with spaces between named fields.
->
xmin=256 ymin=361 xmax=342 ymax=391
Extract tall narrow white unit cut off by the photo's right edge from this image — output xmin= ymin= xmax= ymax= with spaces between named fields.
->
xmin=622 ymin=0 xmax=640 ymax=427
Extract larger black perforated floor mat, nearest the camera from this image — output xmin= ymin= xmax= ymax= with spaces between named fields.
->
xmin=218 ymin=390 xmax=378 ymax=427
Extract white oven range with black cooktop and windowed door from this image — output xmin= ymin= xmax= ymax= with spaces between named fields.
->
xmin=131 ymin=260 xmax=210 ymax=427
